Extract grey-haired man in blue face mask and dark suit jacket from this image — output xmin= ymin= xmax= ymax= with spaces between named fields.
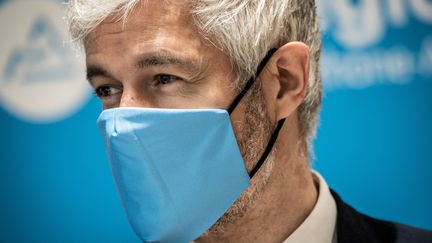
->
xmin=69 ymin=0 xmax=432 ymax=243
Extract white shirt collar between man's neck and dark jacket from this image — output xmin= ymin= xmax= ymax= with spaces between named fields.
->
xmin=283 ymin=171 xmax=337 ymax=243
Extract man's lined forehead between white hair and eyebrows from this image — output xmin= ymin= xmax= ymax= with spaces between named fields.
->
xmin=85 ymin=0 xmax=204 ymax=55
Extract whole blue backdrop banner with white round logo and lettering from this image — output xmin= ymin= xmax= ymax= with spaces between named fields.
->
xmin=0 ymin=0 xmax=432 ymax=242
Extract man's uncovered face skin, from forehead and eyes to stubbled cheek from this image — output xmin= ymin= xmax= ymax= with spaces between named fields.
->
xmin=85 ymin=1 xmax=272 ymax=235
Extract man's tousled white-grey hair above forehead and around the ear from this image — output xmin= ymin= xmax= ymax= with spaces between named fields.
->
xmin=68 ymin=0 xmax=322 ymax=154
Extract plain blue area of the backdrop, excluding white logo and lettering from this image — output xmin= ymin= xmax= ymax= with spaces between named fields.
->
xmin=0 ymin=0 xmax=432 ymax=242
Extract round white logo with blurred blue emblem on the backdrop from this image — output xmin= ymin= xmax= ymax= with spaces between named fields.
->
xmin=0 ymin=1 xmax=89 ymax=122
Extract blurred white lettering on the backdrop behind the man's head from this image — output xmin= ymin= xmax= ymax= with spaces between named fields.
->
xmin=318 ymin=0 xmax=432 ymax=89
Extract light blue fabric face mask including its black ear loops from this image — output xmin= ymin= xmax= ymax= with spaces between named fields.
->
xmin=97 ymin=50 xmax=283 ymax=242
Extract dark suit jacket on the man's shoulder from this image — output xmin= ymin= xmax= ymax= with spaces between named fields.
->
xmin=331 ymin=191 xmax=432 ymax=243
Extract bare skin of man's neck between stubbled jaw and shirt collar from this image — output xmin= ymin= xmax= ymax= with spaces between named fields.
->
xmin=196 ymin=127 xmax=317 ymax=243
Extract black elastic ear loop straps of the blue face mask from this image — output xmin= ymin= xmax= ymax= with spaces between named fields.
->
xmin=223 ymin=48 xmax=285 ymax=179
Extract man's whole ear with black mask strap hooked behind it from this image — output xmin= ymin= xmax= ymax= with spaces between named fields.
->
xmin=260 ymin=42 xmax=309 ymax=121
